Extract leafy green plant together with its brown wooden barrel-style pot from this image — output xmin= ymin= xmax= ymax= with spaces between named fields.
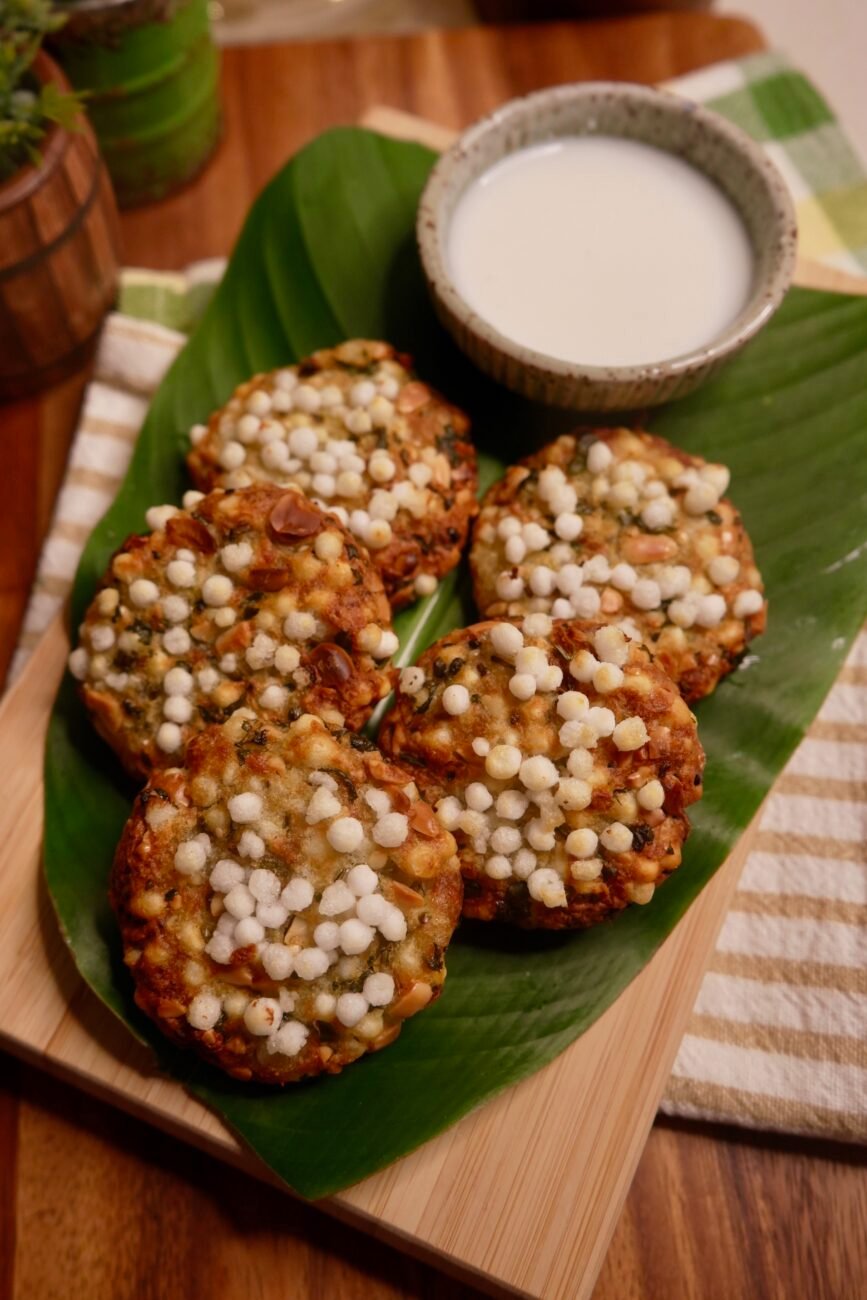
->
xmin=0 ymin=0 xmax=118 ymax=398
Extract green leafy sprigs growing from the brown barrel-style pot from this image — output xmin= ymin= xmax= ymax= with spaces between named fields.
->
xmin=0 ymin=0 xmax=81 ymax=182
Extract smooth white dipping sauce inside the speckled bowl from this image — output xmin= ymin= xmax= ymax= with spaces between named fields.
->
xmin=446 ymin=135 xmax=754 ymax=365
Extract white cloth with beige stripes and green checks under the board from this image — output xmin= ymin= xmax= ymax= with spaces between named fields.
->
xmin=12 ymin=55 xmax=867 ymax=1141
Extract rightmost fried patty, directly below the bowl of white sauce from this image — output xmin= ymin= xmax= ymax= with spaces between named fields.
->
xmin=471 ymin=429 xmax=767 ymax=699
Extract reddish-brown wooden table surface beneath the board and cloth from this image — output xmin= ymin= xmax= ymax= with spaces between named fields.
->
xmin=0 ymin=14 xmax=867 ymax=1300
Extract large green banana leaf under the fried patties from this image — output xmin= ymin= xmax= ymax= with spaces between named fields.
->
xmin=45 ymin=129 xmax=867 ymax=1197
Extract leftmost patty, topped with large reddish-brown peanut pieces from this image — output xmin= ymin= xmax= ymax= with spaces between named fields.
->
xmin=69 ymin=485 xmax=398 ymax=775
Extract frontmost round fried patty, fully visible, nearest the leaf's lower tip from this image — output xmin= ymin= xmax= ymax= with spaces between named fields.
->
xmin=112 ymin=710 xmax=461 ymax=1083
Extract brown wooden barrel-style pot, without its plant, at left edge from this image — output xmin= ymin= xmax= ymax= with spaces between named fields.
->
xmin=0 ymin=51 xmax=118 ymax=398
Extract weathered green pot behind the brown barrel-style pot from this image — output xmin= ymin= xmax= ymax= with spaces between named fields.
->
xmin=53 ymin=0 xmax=220 ymax=207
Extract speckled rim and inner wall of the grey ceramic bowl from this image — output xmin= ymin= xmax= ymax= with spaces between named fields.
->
xmin=416 ymin=81 xmax=798 ymax=386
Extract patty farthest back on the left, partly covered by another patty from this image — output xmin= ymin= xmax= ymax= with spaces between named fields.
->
xmin=187 ymin=339 xmax=478 ymax=608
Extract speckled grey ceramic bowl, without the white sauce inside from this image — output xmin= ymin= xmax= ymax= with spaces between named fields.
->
xmin=417 ymin=82 xmax=797 ymax=411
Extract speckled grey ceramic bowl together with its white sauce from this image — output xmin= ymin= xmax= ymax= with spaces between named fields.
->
xmin=416 ymin=82 xmax=797 ymax=412
